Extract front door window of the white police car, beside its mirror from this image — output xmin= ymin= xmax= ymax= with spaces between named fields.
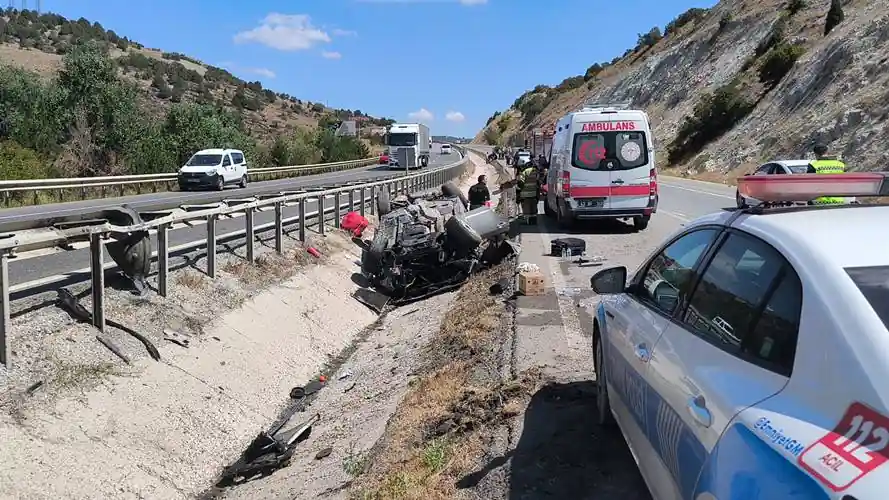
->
xmin=637 ymin=229 xmax=717 ymax=315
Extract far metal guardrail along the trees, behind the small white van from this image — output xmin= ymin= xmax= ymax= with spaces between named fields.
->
xmin=0 ymin=157 xmax=379 ymax=206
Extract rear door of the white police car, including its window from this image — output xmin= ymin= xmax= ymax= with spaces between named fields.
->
xmin=649 ymin=230 xmax=801 ymax=499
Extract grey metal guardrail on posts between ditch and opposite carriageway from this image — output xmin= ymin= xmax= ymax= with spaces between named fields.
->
xmin=0 ymin=149 xmax=469 ymax=369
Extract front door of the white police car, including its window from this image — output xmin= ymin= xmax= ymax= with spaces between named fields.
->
xmin=599 ymin=227 xmax=720 ymax=498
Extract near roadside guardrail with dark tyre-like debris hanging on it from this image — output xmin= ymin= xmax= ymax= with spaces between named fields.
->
xmin=0 ymin=146 xmax=469 ymax=369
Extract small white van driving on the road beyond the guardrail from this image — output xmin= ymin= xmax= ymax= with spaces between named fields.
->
xmin=179 ymin=149 xmax=247 ymax=191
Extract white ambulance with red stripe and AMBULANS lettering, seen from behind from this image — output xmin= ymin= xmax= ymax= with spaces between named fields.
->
xmin=544 ymin=104 xmax=658 ymax=231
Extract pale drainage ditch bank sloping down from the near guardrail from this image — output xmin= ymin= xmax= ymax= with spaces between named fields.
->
xmin=0 ymin=149 xmax=516 ymax=498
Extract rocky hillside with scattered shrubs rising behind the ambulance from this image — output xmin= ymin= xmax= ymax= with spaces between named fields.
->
xmin=475 ymin=0 xmax=876 ymax=176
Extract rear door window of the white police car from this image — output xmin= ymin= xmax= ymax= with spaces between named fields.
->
xmin=685 ymin=233 xmax=801 ymax=374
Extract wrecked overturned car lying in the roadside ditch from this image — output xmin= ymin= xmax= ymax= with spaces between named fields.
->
xmin=356 ymin=183 xmax=515 ymax=310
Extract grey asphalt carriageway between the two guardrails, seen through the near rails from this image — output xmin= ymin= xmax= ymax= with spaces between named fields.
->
xmin=0 ymin=147 xmax=460 ymax=286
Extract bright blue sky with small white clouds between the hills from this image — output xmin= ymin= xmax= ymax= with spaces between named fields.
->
xmin=45 ymin=0 xmax=716 ymax=137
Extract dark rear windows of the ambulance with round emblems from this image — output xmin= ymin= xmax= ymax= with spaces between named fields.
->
xmin=571 ymin=131 xmax=648 ymax=170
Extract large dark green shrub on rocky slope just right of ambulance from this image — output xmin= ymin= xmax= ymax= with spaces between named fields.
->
xmin=668 ymin=85 xmax=753 ymax=164
